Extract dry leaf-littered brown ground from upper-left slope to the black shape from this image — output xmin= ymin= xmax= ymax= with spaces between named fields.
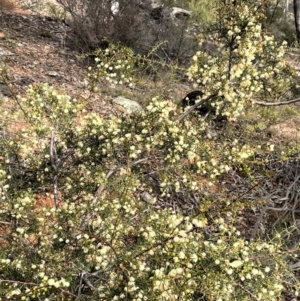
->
xmin=0 ymin=0 xmax=197 ymax=114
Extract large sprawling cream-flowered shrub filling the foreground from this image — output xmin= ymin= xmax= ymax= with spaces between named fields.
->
xmin=0 ymin=81 xmax=296 ymax=300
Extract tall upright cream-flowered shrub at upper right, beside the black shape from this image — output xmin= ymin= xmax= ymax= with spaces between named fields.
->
xmin=189 ymin=1 xmax=299 ymax=120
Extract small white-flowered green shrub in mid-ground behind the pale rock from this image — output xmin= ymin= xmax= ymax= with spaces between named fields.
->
xmin=83 ymin=43 xmax=186 ymax=91
